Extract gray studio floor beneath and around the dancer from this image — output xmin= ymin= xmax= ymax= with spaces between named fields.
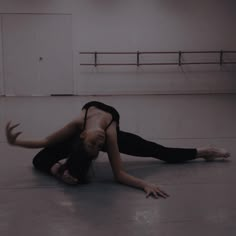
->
xmin=0 ymin=95 xmax=236 ymax=236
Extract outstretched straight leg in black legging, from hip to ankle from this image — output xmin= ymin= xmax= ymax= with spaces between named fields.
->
xmin=117 ymin=131 xmax=197 ymax=163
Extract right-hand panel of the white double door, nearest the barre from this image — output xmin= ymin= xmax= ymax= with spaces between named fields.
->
xmin=35 ymin=15 xmax=74 ymax=94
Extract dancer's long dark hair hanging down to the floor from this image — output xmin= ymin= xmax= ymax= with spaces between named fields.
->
xmin=65 ymin=138 xmax=93 ymax=183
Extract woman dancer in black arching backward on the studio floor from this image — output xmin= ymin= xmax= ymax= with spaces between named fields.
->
xmin=6 ymin=101 xmax=230 ymax=198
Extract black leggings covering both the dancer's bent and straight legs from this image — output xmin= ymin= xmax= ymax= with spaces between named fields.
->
xmin=33 ymin=130 xmax=197 ymax=174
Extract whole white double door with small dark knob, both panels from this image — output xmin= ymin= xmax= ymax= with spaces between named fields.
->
xmin=3 ymin=14 xmax=73 ymax=95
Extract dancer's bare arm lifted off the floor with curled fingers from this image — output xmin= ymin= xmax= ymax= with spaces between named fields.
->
xmin=5 ymin=119 xmax=80 ymax=148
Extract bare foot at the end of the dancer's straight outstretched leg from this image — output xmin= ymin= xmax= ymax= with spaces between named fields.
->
xmin=197 ymin=147 xmax=230 ymax=161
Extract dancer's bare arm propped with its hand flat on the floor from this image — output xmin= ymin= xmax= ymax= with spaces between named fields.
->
xmin=106 ymin=123 xmax=169 ymax=198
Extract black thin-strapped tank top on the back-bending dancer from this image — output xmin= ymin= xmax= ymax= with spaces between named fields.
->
xmin=82 ymin=101 xmax=120 ymax=131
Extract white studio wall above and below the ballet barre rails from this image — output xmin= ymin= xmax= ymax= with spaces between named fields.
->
xmin=0 ymin=0 xmax=236 ymax=94
